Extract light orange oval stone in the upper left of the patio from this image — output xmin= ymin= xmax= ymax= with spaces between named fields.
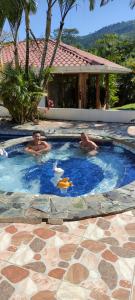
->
xmin=11 ymin=231 xmax=33 ymax=246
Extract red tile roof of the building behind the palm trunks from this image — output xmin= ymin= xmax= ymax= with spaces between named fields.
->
xmin=2 ymin=40 xmax=127 ymax=69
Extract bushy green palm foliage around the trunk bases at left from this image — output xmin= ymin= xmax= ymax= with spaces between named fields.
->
xmin=0 ymin=64 xmax=44 ymax=124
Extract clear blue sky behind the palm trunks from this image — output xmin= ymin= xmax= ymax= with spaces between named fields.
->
xmin=4 ymin=0 xmax=135 ymax=40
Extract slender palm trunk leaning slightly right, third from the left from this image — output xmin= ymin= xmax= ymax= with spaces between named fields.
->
xmin=39 ymin=0 xmax=52 ymax=80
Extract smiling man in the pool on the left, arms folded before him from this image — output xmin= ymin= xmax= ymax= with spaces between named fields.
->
xmin=25 ymin=131 xmax=51 ymax=156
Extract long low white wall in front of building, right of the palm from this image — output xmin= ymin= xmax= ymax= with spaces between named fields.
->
xmin=39 ymin=107 xmax=135 ymax=123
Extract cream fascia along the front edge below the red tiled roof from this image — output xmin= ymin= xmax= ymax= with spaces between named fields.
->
xmin=51 ymin=65 xmax=132 ymax=74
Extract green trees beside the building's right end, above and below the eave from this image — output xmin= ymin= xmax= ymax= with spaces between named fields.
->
xmin=90 ymin=34 xmax=135 ymax=107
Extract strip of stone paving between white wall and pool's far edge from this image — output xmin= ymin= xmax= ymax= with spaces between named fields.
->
xmin=0 ymin=118 xmax=135 ymax=139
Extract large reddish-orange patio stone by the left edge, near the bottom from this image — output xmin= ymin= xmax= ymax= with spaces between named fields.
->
xmin=1 ymin=265 xmax=29 ymax=283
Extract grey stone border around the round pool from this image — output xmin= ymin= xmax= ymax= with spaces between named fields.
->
xmin=0 ymin=134 xmax=135 ymax=224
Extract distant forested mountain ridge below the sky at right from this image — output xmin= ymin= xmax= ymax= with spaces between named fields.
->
xmin=76 ymin=20 xmax=135 ymax=49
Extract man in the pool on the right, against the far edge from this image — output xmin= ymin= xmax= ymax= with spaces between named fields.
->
xmin=80 ymin=133 xmax=98 ymax=155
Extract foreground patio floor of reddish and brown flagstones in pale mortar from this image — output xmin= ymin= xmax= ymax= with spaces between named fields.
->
xmin=0 ymin=210 xmax=135 ymax=300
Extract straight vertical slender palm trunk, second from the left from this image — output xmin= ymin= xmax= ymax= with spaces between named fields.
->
xmin=25 ymin=7 xmax=30 ymax=80
